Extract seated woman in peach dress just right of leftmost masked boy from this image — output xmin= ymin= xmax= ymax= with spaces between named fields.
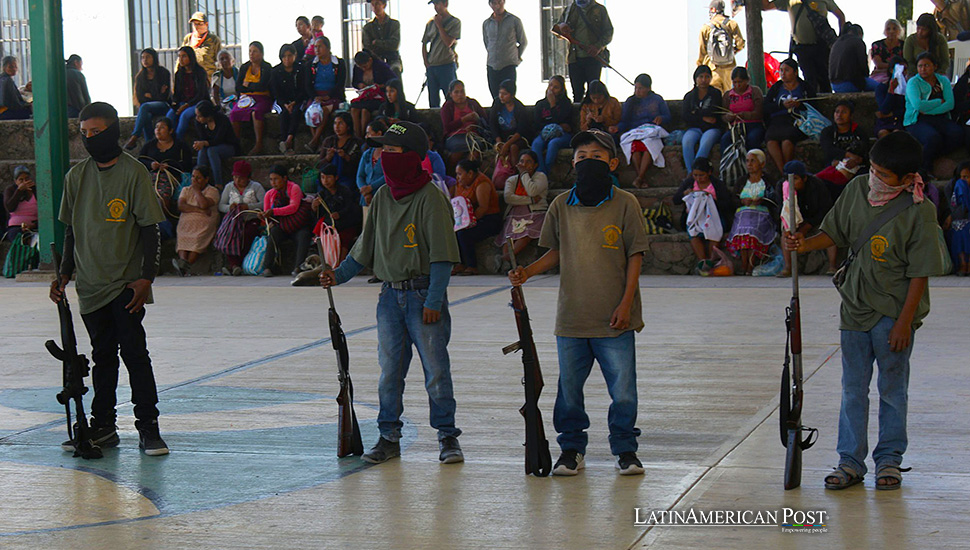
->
xmin=172 ymin=166 xmax=219 ymax=277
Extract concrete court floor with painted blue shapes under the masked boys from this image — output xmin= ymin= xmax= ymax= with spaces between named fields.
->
xmin=0 ymin=277 xmax=970 ymax=549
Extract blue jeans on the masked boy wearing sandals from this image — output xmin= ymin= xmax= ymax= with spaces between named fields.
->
xmin=836 ymin=317 xmax=913 ymax=475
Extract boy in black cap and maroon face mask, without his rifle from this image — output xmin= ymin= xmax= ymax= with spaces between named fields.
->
xmin=320 ymin=122 xmax=464 ymax=464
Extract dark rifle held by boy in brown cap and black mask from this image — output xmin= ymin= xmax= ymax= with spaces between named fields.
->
xmin=502 ymin=239 xmax=552 ymax=477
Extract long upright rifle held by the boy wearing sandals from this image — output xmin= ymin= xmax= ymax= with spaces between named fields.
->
xmin=779 ymin=178 xmax=818 ymax=491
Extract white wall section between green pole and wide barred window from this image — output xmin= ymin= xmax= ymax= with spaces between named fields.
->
xmin=62 ymin=0 xmax=132 ymax=116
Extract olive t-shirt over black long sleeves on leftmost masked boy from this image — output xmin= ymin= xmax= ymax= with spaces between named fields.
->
xmin=58 ymin=153 xmax=165 ymax=314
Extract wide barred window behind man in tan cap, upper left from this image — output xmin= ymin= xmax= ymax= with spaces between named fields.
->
xmin=128 ymin=0 xmax=242 ymax=78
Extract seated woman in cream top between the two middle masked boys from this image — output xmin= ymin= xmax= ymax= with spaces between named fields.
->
xmin=495 ymin=149 xmax=549 ymax=261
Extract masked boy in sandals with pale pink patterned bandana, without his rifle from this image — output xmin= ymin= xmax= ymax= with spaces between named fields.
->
xmin=785 ymin=132 xmax=952 ymax=490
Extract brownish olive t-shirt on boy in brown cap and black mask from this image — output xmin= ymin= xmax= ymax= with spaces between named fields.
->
xmin=539 ymin=187 xmax=650 ymax=338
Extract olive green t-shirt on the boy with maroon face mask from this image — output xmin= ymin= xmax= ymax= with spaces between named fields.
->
xmin=350 ymin=184 xmax=461 ymax=283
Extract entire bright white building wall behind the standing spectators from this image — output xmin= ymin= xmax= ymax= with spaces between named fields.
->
xmin=56 ymin=0 xmax=908 ymax=115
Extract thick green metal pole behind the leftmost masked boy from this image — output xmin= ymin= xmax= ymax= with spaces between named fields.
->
xmin=29 ymin=0 xmax=70 ymax=265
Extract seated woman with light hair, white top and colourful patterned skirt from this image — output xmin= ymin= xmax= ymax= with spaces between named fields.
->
xmin=727 ymin=149 xmax=777 ymax=275
